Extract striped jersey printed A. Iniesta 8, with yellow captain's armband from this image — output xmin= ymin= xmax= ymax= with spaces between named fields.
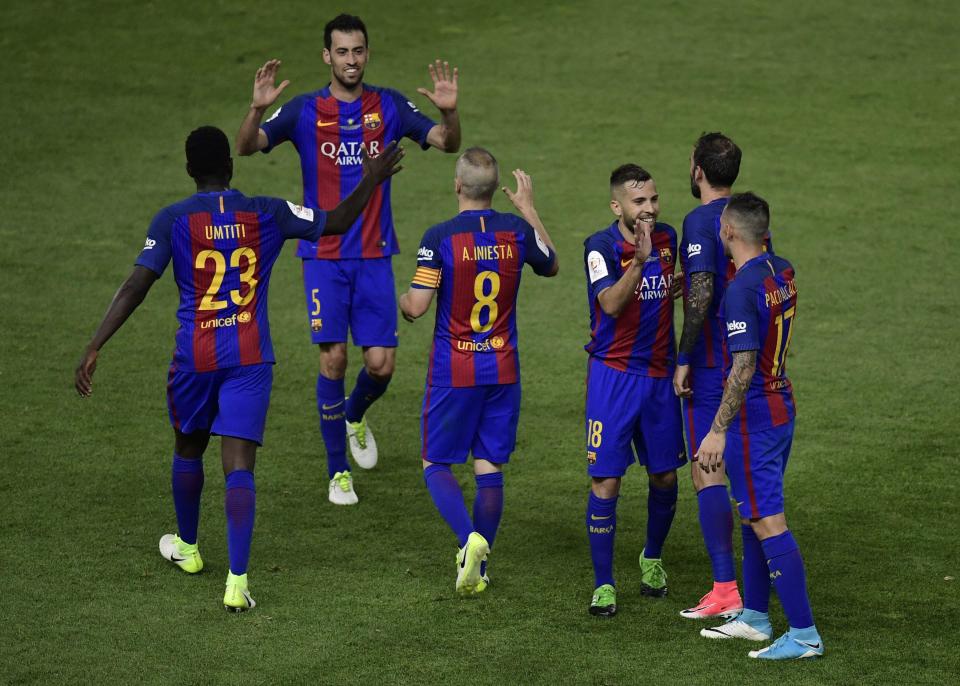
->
xmin=411 ymin=209 xmax=556 ymax=388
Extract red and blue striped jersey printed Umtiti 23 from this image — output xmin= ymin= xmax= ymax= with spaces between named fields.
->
xmin=136 ymin=190 xmax=327 ymax=372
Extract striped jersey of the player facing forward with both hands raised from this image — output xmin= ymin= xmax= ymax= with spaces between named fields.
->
xmin=260 ymin=85 xmax=435 ymax=260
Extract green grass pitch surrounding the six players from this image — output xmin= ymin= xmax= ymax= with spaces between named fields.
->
xmin=0 ymin=0 xmax=960 ymax=685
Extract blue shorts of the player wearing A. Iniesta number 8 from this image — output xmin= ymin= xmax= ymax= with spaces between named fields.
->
xmin=420 ymin=383 xmax=520 ymax=464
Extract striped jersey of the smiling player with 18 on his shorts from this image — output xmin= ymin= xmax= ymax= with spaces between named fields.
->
xmin=583 ymin=221 xmax=677 ymax=377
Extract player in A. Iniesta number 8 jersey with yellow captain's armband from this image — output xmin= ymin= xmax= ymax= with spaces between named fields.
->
xmin=400 ymin=148 xmax=559 ymax=595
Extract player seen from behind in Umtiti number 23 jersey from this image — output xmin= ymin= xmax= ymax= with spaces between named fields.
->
xmin=75 ymin=126 xmax=403 ymax=612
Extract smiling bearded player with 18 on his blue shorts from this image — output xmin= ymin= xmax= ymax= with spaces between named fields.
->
xmin=584 ymin=164 xmax=686 ymax=617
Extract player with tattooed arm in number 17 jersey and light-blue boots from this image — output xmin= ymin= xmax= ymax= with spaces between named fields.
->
xmin=697 ymin=193 xmax=823 ymax=660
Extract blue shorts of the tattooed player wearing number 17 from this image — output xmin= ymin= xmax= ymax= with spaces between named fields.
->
xmin=723 ymin=419 xmax=793 ymax=519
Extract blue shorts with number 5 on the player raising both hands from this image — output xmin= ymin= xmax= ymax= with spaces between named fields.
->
xmin=303 ymin=257 xmax=398 ymax=348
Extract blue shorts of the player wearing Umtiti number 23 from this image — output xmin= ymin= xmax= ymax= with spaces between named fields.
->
xmin=167 ymin=362 xmax=273 ymax=445
